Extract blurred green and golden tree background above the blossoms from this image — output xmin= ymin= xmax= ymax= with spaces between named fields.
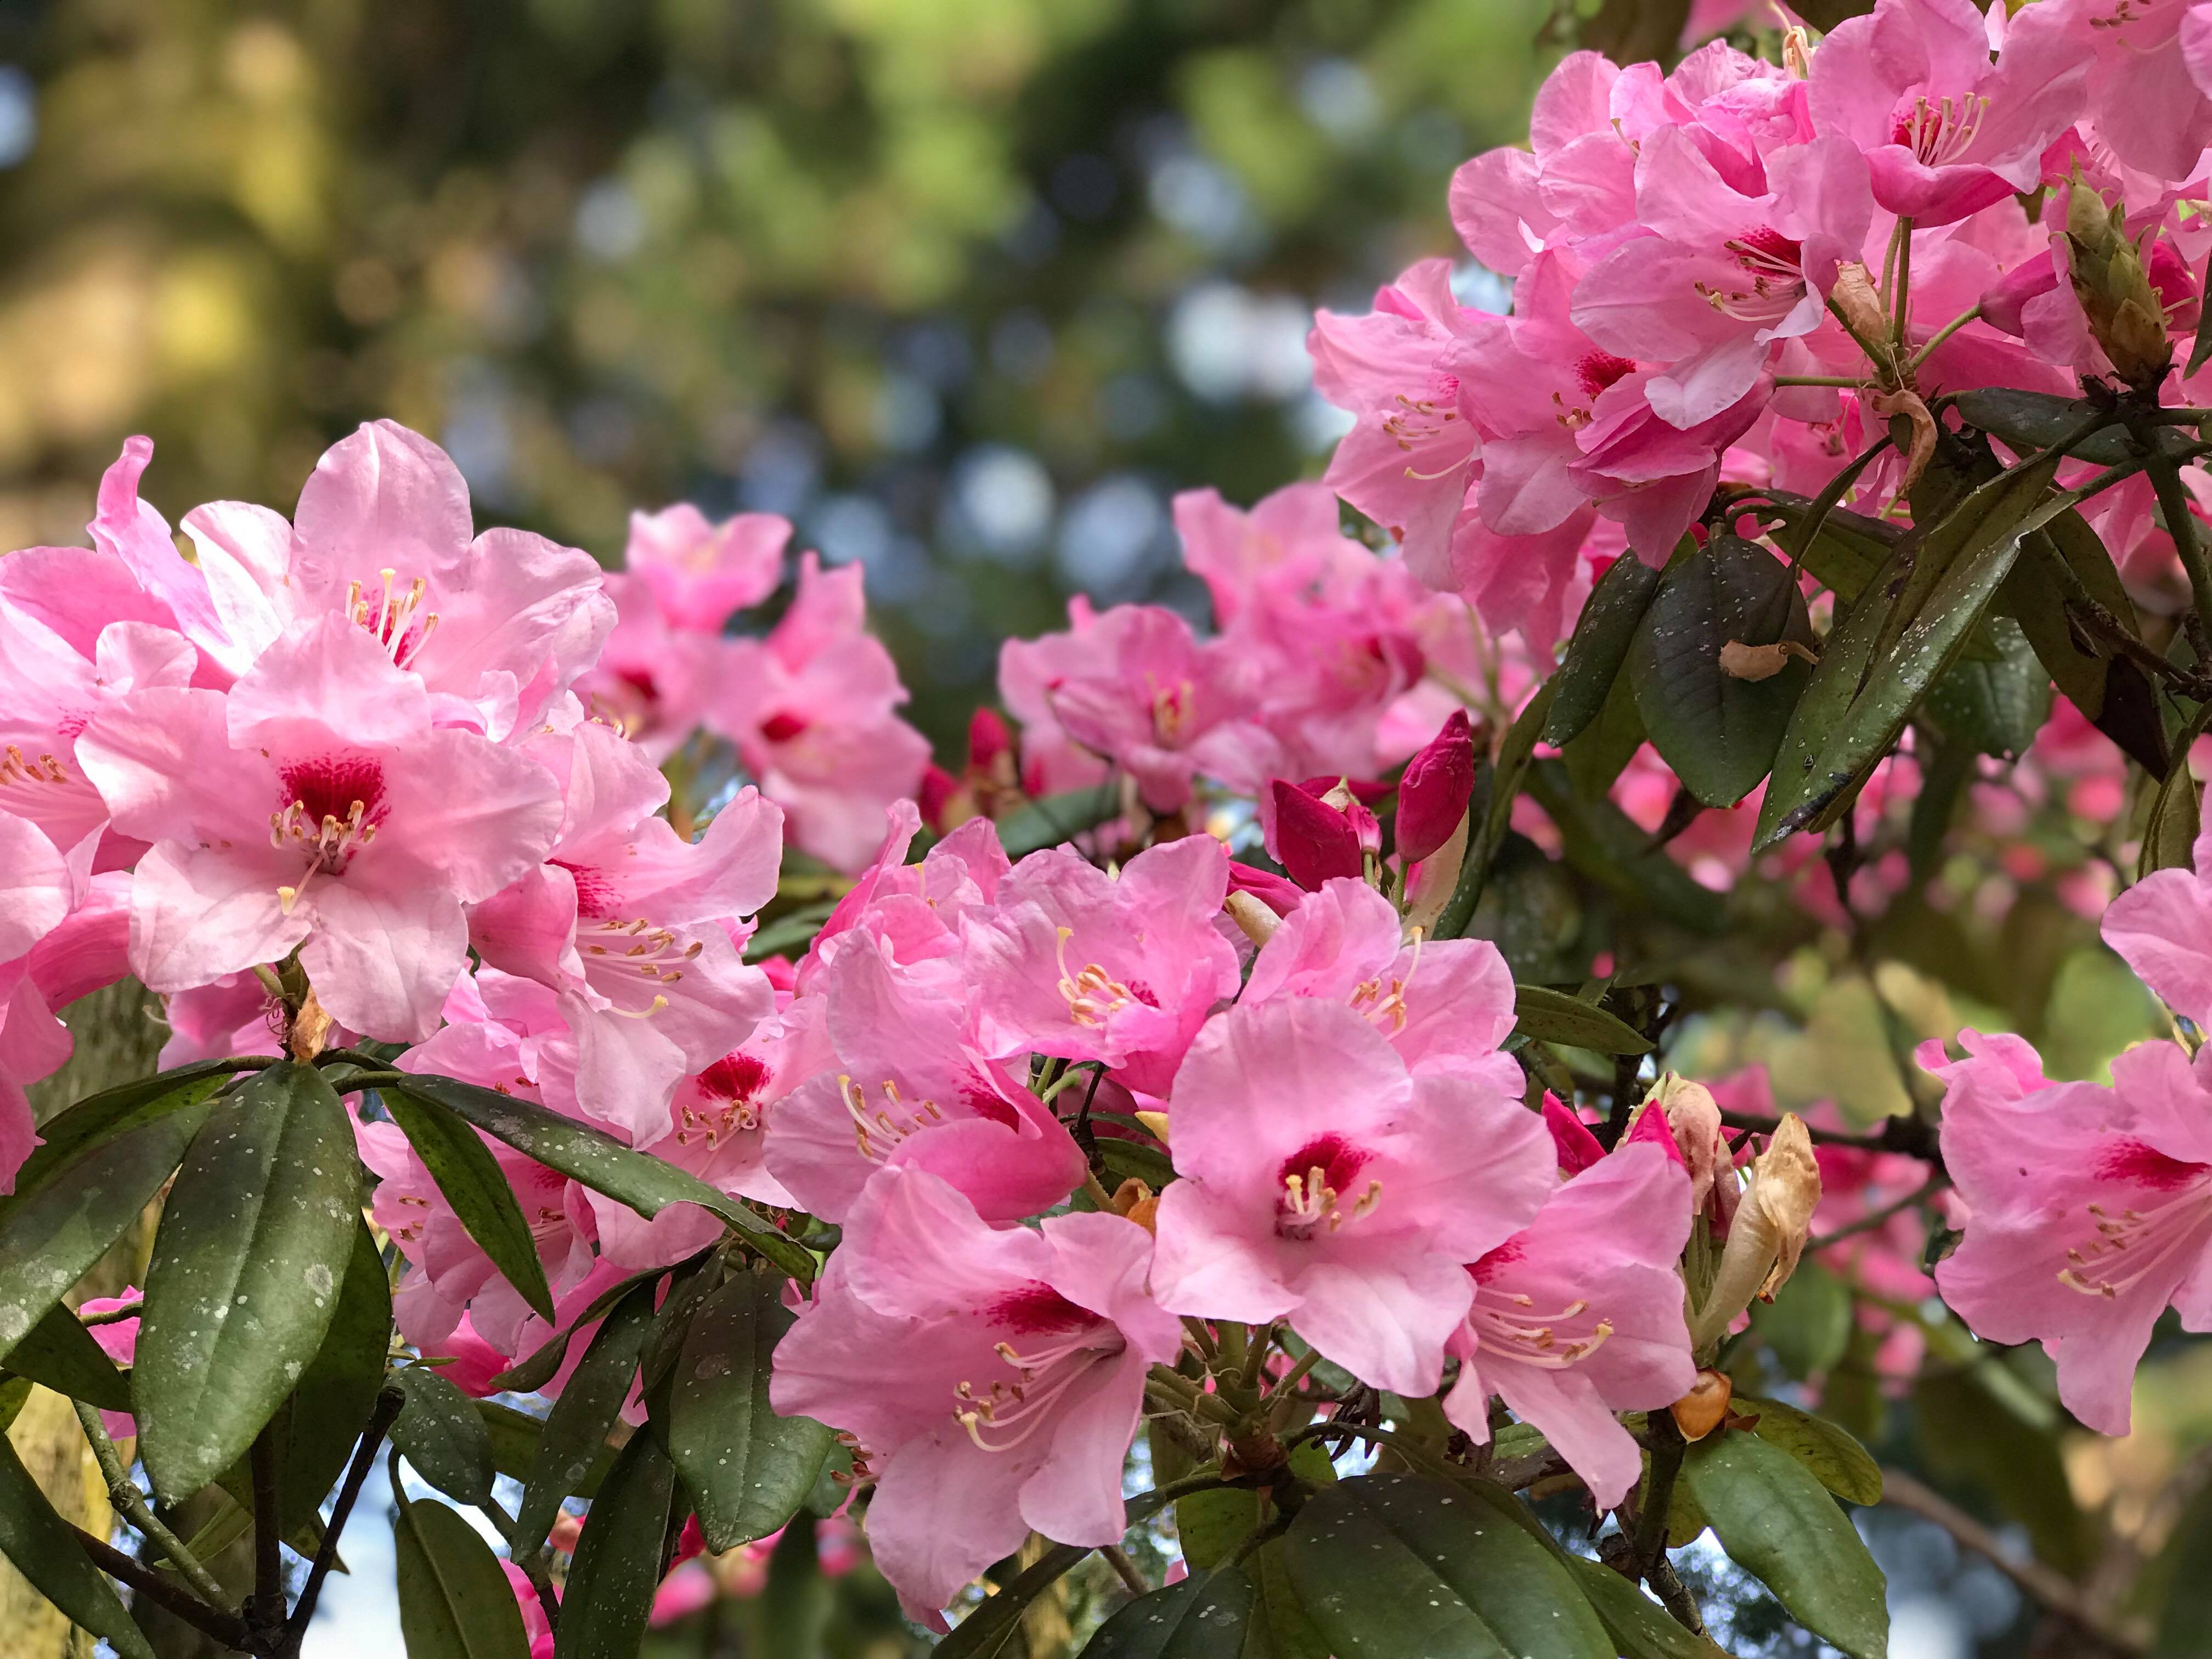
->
xmin=0 ymin=0 xmax=1558 ymax=761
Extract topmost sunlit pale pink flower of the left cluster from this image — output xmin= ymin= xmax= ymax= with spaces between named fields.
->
xmin=184 ymin=420 xmax=615 ymax=739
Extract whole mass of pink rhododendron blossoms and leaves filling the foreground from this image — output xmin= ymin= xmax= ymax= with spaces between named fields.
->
xmin=21 ymin=0 xmax=2212 ymax=1659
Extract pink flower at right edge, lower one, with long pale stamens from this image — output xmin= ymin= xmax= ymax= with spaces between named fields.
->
xmin=1920 ymin=1031 xmax=2212 ymax=1434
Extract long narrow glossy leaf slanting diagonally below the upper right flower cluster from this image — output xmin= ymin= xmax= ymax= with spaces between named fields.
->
xmin=1752 ymin=456 xmax=2059 ymax=849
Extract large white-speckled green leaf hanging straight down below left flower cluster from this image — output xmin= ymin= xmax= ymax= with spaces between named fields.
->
xmin=131 ymin=1062 xmax=360 ymax=1502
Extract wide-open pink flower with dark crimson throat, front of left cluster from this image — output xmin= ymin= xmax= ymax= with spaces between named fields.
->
xmin=77 ymin=615 xmax=560 ymax=1042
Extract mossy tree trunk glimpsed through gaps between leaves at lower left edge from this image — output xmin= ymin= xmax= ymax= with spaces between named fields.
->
xmin=0 ymin=980 xmax=166 ymax=1659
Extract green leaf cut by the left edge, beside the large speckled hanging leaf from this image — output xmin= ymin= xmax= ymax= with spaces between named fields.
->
xmin=0 ymin=1080 xmax=221 ymax=1361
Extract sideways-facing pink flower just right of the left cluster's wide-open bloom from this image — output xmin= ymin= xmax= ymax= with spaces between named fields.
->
xmin=469 ymin=723 xmax=783 ymax=1144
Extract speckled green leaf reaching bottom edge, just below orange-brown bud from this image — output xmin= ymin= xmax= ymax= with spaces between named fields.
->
xmin=1681 ymin=1431 xmax=1889 ymax=1659
